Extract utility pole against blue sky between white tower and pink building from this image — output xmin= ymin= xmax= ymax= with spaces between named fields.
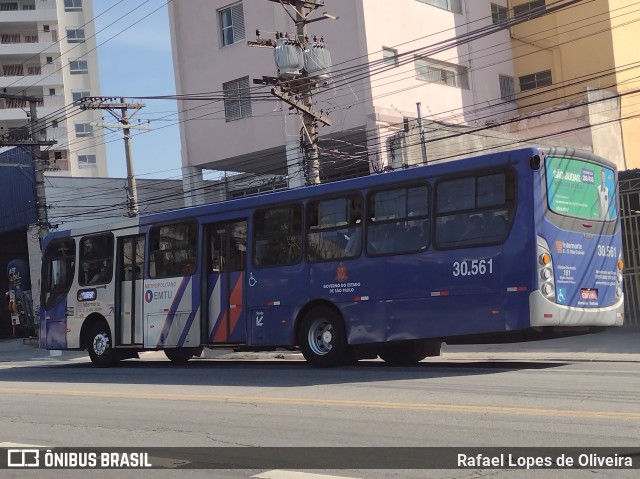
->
xmin=80 ymin=97 xmax=145 ymax=218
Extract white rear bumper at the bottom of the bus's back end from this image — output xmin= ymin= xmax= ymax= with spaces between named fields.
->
xmin=529 ymin=291 xmax=624 ymax=327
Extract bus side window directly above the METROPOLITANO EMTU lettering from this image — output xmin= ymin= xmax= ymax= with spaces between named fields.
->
xmin=149 ymin=222 xmax=198 ymax=278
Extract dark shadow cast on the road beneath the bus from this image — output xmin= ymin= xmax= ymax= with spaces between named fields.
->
xmin=0 ymin=359 xmax=571 ymax=388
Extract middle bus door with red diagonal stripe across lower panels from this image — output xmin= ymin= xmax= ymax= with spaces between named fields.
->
xmin=203 ymin=220 xmax=247 ymax=344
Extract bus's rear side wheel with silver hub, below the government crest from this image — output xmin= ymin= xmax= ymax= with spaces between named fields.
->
xmin=298 ymin=306 xmax=352 ymax=368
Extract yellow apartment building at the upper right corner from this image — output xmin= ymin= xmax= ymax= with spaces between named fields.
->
xmin=504 ymin=0 xmax=640 ymax=169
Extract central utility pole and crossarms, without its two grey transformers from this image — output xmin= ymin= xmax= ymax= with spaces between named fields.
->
xmin=248 ymin=0 xmax=337 ymax=185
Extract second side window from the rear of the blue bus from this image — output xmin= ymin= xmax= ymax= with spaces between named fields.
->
xmin=367 ymin=186 xmax=430 ymax=255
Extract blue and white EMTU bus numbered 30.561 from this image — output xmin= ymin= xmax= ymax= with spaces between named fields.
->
xmin=39 ymin=147 xmax=623 ymax=367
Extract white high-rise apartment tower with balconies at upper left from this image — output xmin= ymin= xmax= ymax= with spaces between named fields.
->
xmin=0 ymin=0 xmax=107 ymax=177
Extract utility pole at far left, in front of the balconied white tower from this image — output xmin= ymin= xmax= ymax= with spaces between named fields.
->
xmin=0 ymin=93 xmax=57 ymax=241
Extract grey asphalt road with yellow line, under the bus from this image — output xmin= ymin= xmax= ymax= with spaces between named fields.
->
xmin=0 ymin=349 xmax=640 ymax=479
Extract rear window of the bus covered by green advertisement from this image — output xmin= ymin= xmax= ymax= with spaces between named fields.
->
xmin=546 ymin=156 xmax=618 ymax=221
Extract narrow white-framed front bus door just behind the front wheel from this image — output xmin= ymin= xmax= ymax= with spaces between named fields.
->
xmin=114 ymin=235 xmax=145 ymax=346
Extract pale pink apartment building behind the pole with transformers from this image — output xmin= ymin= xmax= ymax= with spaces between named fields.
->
xmin=168 ymin=0 xmax=516 ymax=195
